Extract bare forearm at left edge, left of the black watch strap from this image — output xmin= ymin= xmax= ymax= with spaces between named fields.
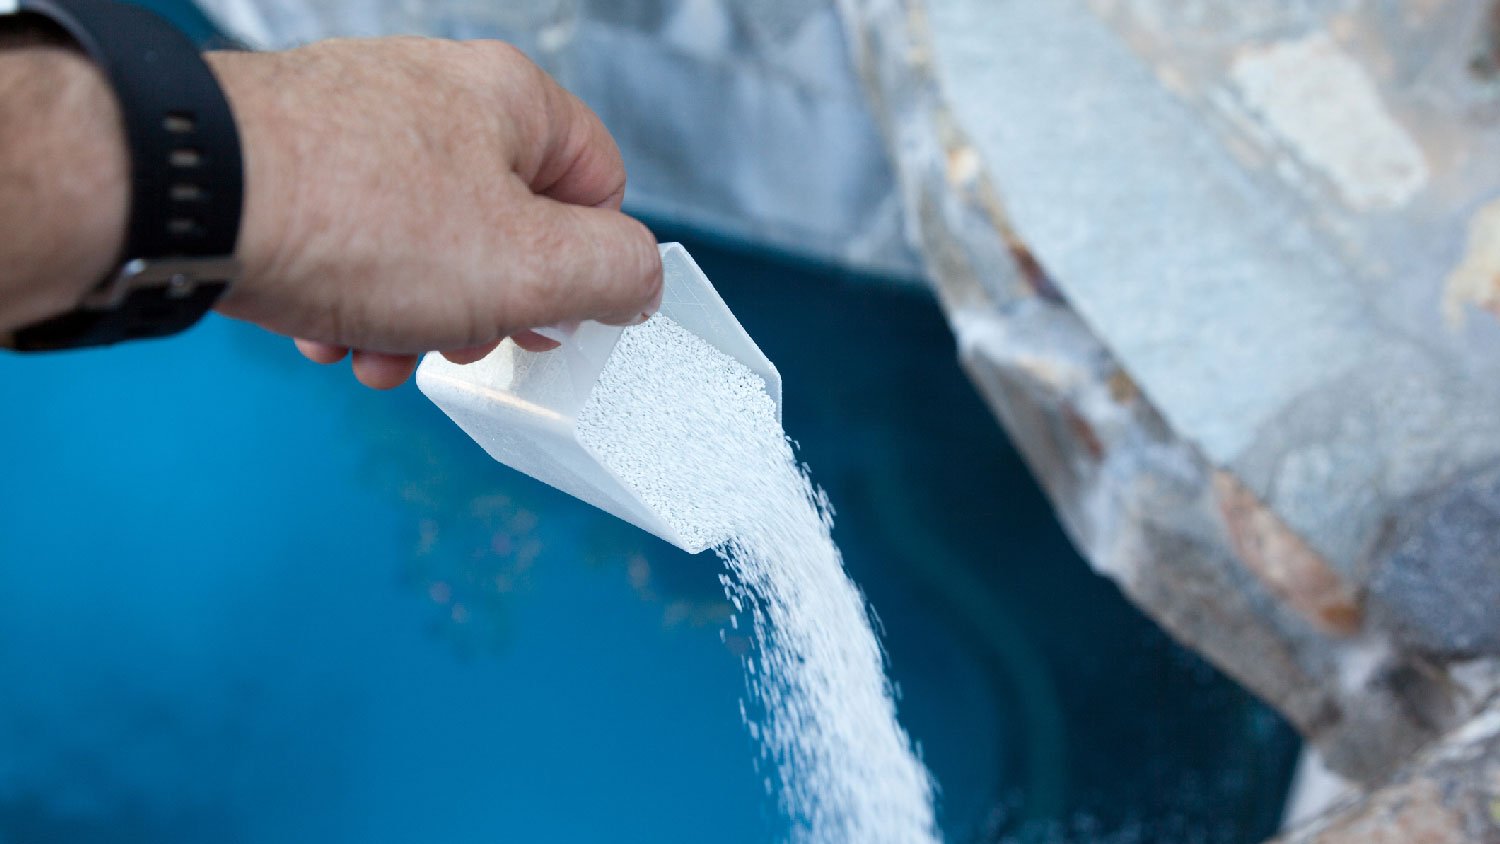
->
xmin=0 ymin=43 xmax=129 ymax=334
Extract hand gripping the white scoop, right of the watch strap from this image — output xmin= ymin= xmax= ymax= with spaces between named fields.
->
xmin=209 ymin=37 xmax=662 ymax=388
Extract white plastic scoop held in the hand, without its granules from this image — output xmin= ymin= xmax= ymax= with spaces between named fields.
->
xmin=417 ymin=243 xmax=782 ymax=553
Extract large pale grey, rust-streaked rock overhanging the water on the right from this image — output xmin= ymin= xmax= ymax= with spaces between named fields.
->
xmin=842 ymin=0 xmax=1500 ymax=783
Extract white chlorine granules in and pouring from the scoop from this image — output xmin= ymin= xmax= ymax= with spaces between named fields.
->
xmin=578 ymin=316 xmax=936 ymax=844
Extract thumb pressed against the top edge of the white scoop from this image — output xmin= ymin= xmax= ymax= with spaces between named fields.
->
xmin=506 ymin=196 xmax=662 ymax=328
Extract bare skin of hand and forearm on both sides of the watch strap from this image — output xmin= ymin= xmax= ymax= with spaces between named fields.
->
xmin=0 ymin=37 xmax=662 ymax=388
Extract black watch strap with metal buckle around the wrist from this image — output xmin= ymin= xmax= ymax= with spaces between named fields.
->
xmin=14 ymin=0 xmax=245 ymax=351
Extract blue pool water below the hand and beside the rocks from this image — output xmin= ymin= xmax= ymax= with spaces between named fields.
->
xmin=0 ymin=232 xmax=1296 ymax=844
